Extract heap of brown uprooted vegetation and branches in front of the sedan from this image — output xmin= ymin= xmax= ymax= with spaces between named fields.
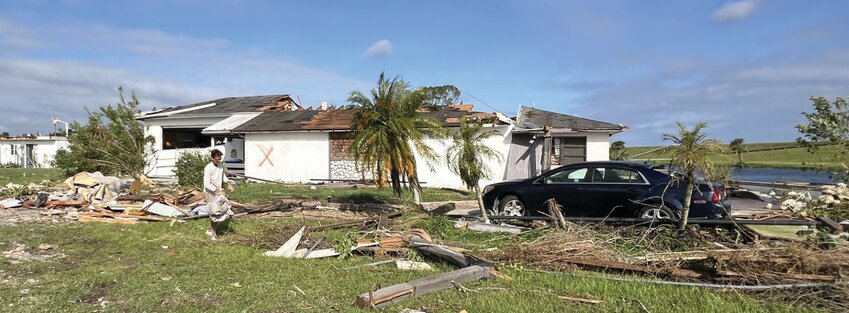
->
xmin=485 ymin=224 xmax=849 ymax=312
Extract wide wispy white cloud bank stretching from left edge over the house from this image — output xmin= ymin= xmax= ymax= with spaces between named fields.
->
xmin=0 ymin=20 xmax=371 ymax=134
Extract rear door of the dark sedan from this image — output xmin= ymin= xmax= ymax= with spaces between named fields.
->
xmin=583 ymin=166 xmax=650 ymax=217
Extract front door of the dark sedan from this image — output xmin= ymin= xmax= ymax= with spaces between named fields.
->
xmin=543 ymin=167 xmax=590 ymax=216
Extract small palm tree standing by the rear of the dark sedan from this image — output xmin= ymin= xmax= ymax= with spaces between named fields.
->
xmin=663 ymin=122 xmax=723 ymax=229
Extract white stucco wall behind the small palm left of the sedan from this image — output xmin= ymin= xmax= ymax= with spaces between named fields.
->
xmin=416 ymin=126 xmax=512 ymax=189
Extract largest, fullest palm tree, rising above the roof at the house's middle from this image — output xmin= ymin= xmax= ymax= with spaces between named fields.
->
xmin=348 ymin=73 xmax=442 ymax=203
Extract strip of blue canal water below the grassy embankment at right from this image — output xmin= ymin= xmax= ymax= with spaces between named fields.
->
xmin=731 ymin=167 xmax=835 ymax=184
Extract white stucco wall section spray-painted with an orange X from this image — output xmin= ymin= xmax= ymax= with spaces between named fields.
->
xmin=245 ymin=132 xmax=330 ymax=183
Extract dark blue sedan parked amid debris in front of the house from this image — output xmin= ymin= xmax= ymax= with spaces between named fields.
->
xmin=483 ymin=161 xmax=730 ymax=219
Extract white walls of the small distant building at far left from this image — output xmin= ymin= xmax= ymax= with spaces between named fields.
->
xmin=0 ymin=137 xmax=68 ymax=168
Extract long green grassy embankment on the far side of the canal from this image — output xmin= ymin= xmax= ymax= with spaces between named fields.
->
xmin=626 ymin=142 xmax=842 ymax=169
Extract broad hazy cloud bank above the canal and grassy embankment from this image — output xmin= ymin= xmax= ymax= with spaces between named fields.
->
xmin=554 ymin=51 xmax=849 ymax=145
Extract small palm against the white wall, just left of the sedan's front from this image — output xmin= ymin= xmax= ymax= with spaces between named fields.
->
xmin=445 ymin=119 xmax=501 ymax=219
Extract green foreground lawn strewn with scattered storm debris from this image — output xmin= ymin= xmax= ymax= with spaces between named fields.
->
xmin=0 ymin=218 xmax=820 ymax=312
